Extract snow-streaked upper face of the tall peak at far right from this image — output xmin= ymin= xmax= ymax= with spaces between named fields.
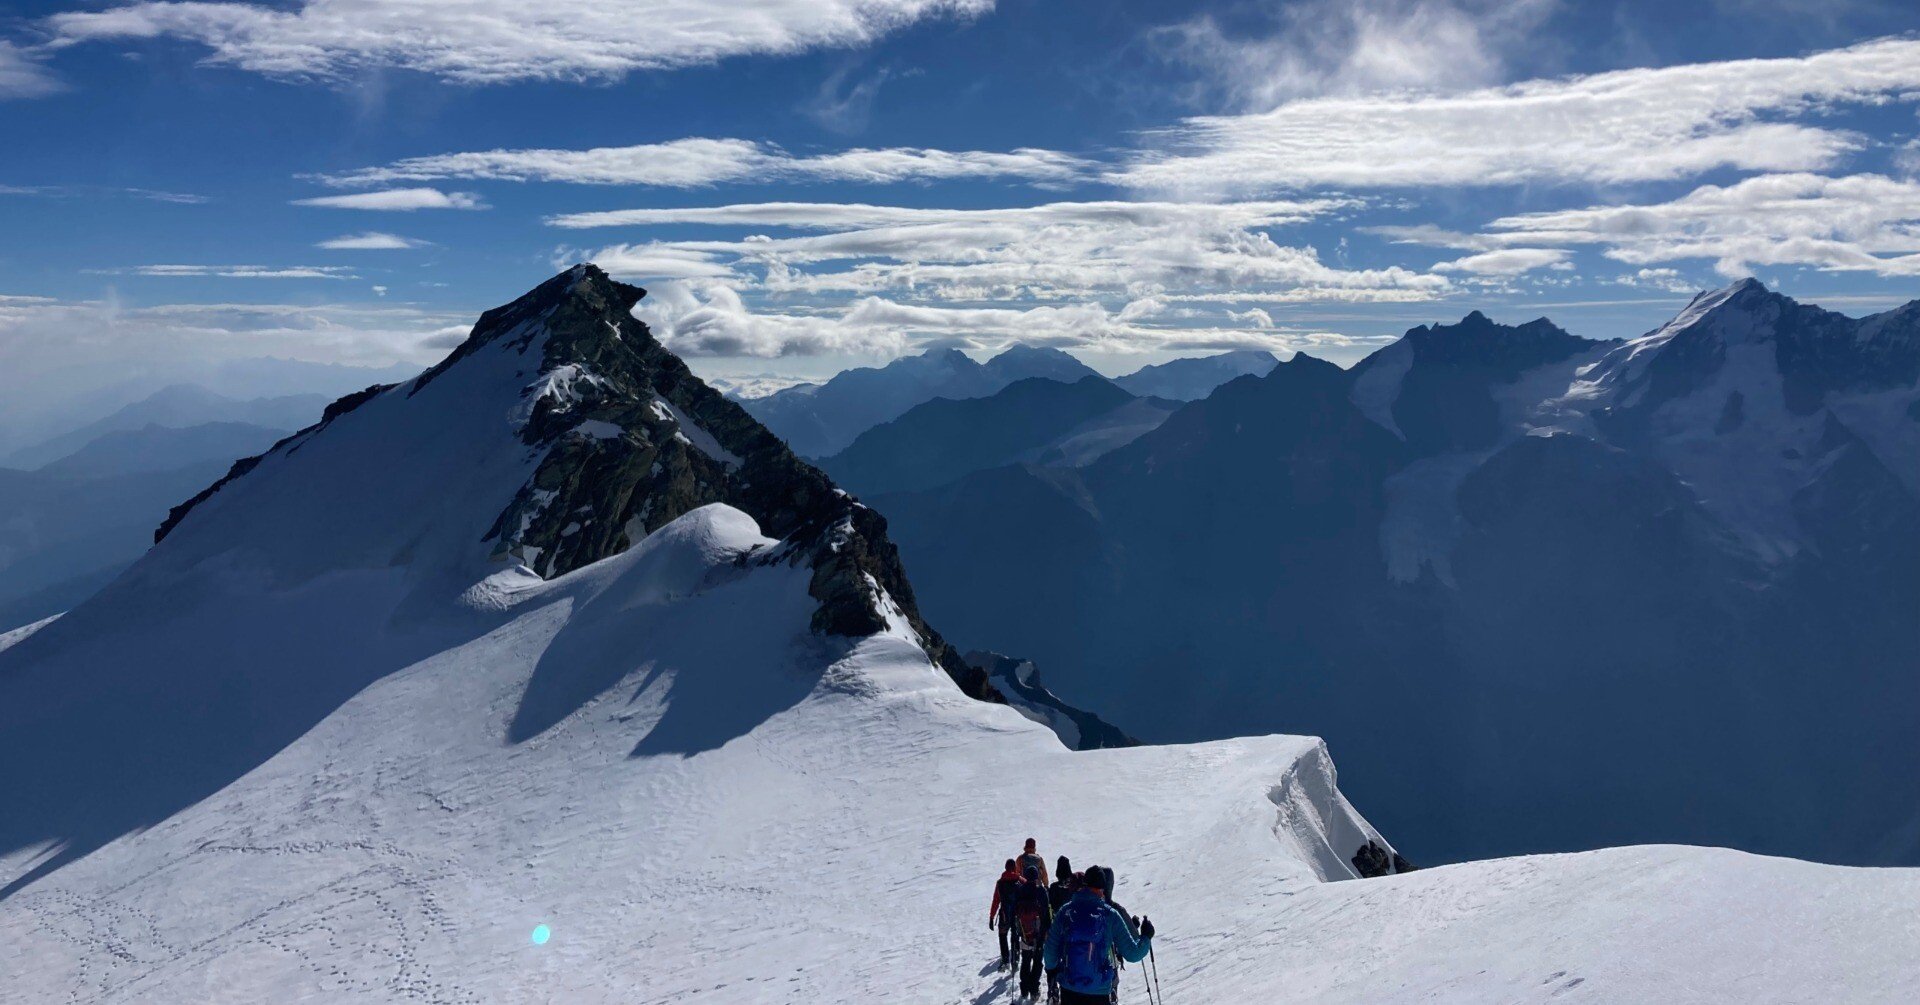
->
xmin=1528 ymin=279 xmax=1920 ymax=565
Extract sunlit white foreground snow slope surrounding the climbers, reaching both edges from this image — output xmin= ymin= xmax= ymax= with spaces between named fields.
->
xmin=0 ymin=503 xmax=1920 ymax=1003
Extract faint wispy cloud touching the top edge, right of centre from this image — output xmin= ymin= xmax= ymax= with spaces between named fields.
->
xmin=1146 ymin=0 xmax=1559 ymax=111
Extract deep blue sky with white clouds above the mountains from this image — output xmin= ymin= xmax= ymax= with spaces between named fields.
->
xmin=0 ymin=0 xmax=1920 ymax=390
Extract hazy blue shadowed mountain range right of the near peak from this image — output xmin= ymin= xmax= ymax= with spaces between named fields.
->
xmin=868 ymin=281 xmax=1920 ymax=863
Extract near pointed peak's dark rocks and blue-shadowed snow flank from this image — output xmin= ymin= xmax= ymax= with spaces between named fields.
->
xmin=0 ymin=267 xmax=993 ymax=891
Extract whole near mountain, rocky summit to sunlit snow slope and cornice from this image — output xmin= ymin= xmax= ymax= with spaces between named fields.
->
xmin=0 ymin=267 xmax=1384 ymax=1001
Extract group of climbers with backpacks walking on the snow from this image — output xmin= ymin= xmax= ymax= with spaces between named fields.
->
xmin=987 ymin=838 xmax=1154 ymax=1005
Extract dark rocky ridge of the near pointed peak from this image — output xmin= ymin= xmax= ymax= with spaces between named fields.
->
xmin=156 ymin=265 xmax=995 ymax=698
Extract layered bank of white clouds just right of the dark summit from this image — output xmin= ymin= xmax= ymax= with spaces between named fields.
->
xmin=549 ymin=196 xmax=1452 ymax=357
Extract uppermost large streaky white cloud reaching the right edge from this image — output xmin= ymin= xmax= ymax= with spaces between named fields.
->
xmin=1112 ymin=38 xmax=1920 ymax=194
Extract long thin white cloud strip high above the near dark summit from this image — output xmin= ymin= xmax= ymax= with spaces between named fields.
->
xmin=321 ymin=136 xmax=1094 ymax=188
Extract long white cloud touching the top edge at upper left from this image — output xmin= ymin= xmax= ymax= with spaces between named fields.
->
xmin=48 ymin=0 xmax=993 ymax=85
